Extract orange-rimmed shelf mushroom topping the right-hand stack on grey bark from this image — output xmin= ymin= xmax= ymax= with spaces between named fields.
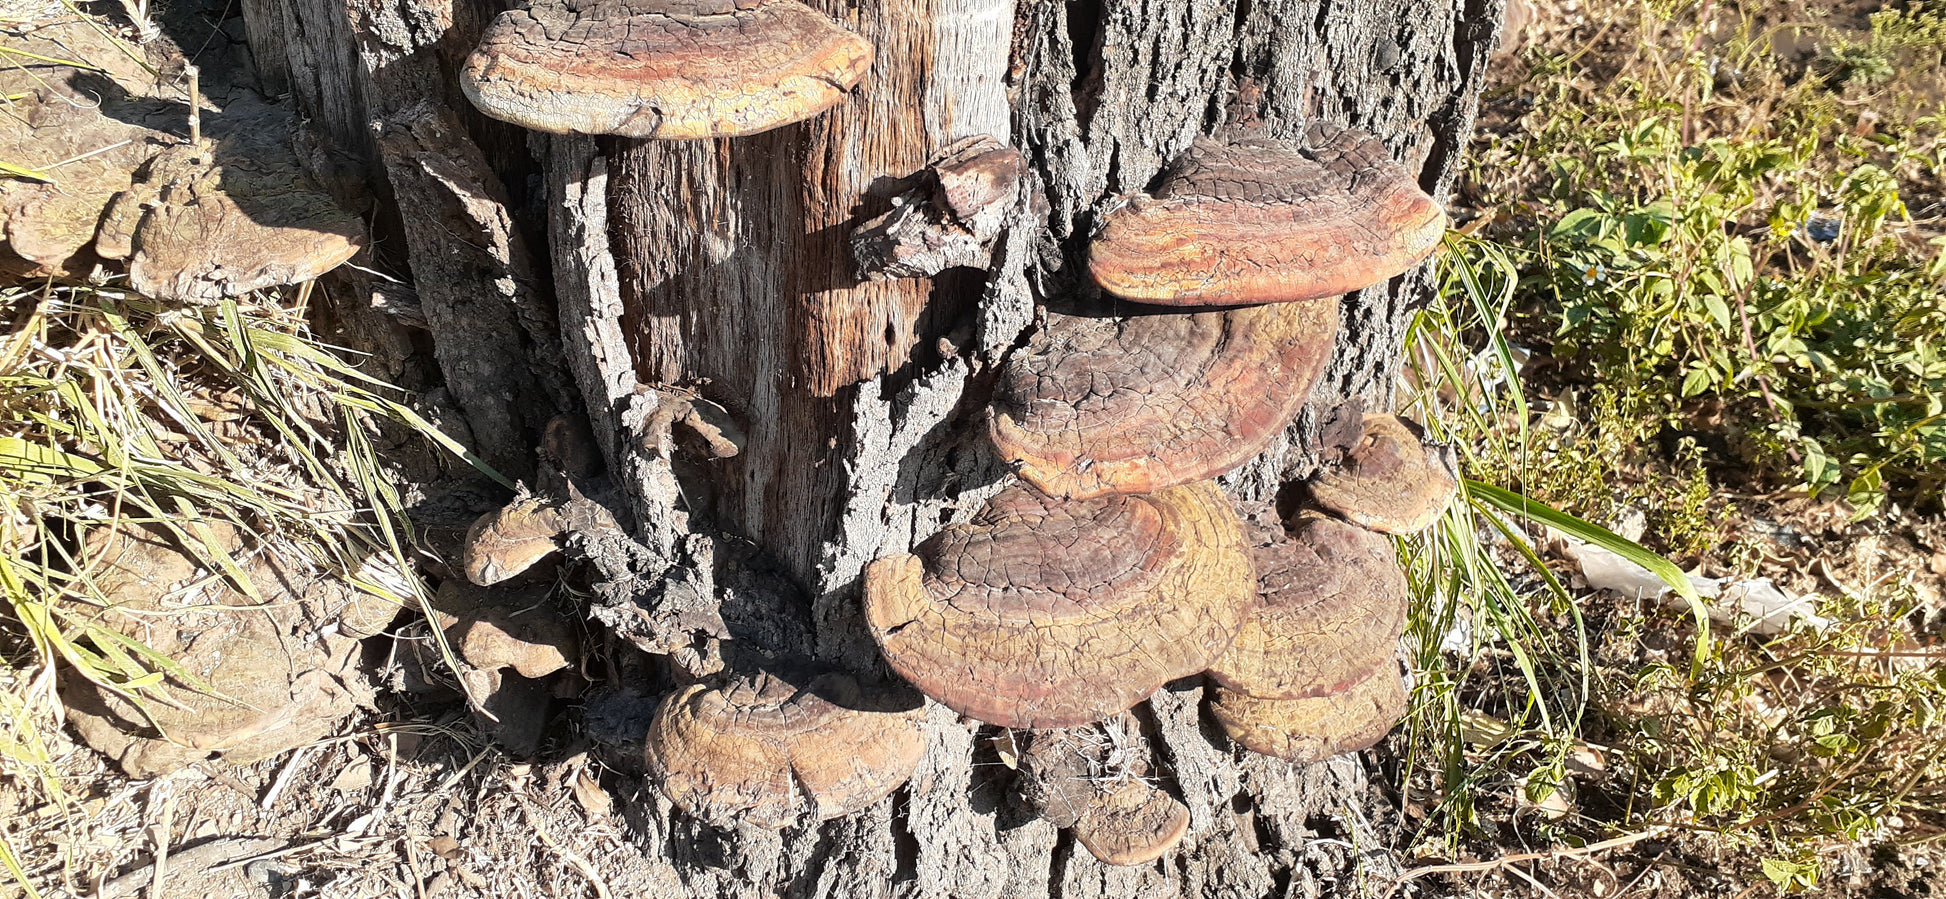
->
xmin=1088 ymin=123 xmax=1446 ymax=306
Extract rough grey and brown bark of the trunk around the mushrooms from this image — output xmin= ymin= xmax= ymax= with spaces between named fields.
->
xmin=243 ymin=0 xmax=1500 ymax=897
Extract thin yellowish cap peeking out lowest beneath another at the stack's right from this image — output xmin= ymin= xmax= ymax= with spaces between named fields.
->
xmin=1210 ymin=665 xmax=1405 ymax=763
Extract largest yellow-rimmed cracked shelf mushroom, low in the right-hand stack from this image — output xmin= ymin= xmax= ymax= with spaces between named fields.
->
xmin=864 ymin=481 xmax=1257 ymax=728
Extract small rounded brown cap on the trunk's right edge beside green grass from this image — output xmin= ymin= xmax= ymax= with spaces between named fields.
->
xmin=1306 ymin=414 xmax=1460 ymax=533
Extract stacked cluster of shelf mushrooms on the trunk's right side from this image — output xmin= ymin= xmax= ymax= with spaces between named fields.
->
xmin=864 ymin=125 xmax=1456 ymax=828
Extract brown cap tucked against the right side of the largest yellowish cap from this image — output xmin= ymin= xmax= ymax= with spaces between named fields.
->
xmin=1210 ymin=516 xmax=1409 ymax=699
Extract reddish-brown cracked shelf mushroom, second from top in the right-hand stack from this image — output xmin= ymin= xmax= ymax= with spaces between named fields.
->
xmin=989 ymin=298 xmax=1339 ymax=498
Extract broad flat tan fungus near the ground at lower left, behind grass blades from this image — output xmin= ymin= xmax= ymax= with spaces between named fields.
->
xmin=62 ymin=521 xmax=381 ymax=776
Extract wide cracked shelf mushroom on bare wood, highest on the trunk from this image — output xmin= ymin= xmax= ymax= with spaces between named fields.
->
xmin=459 ymin=0 xmax=872 ymax=140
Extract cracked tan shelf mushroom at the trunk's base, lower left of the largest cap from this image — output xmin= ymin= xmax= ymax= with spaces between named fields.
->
xmin=644 ymin=665 xmax=924 ymax=827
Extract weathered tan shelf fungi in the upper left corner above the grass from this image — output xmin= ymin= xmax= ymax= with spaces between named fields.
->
xmin=0 ymin=19 xmax=366 ymax=304
